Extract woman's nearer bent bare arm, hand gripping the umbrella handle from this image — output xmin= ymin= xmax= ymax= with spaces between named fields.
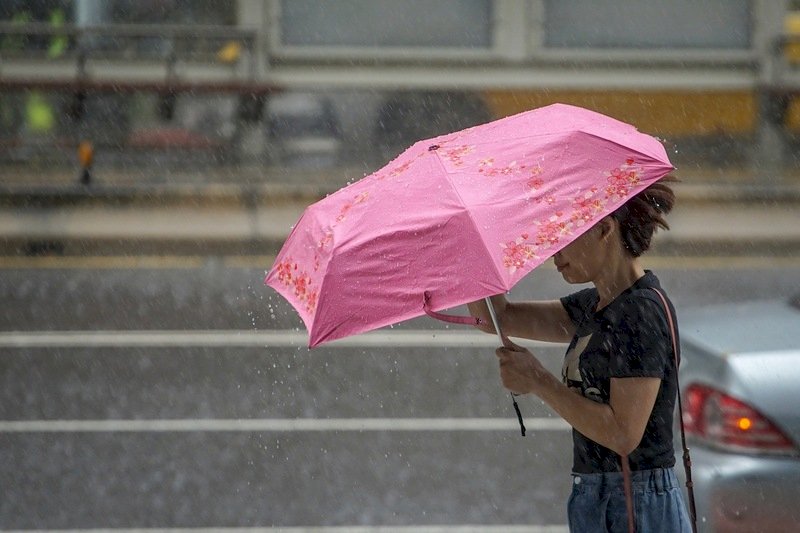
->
xmin=497 ymin=342 xmax=661 ymax=455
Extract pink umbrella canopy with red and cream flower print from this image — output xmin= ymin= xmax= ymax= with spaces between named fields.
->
xmin=265 ymin=104 xmax=673 ymax=347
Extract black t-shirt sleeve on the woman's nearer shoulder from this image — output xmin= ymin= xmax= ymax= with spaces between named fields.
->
xmin=606 ymin=293 xmax=672 ymax=378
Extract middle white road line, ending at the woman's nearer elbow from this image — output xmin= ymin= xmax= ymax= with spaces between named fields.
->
xmin=0 ymin=417 xmax=570 ymax=433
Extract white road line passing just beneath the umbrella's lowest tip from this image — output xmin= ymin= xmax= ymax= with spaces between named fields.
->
xmin=0 ymin=329 xmax=564 ymax=349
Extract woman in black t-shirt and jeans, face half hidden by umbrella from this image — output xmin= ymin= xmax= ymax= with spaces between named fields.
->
xmin=469 ymin=179 xmax=691 ymax=532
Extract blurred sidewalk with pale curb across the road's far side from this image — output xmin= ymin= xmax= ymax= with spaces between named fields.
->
xmin=0 ymin=166 xmax=800 ymax=256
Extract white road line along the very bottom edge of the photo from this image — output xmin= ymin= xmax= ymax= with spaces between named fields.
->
xmin=0 ymin=524 xmax=568 ymax=533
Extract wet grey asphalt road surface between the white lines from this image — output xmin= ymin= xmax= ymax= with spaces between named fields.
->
xmin=0 ymin=258 xmax=800 ymax=529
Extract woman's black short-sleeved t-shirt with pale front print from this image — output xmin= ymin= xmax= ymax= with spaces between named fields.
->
xmin=561 ymin=271 xmax=678 ymax=473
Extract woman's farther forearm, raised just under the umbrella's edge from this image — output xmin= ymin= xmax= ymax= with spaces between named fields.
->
xmin=467 ymin=294 xmax=575 ymax=342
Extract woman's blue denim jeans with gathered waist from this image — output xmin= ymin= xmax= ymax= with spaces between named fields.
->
xmin=567 ymin=468 xmax=692 ymax=533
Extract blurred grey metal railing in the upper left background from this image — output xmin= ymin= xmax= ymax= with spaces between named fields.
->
xmin=0 ymin=22 xmax=273 ymax=94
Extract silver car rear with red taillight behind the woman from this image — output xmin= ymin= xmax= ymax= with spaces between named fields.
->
xmin=676 ymin=298 xmax=800 ymax=532
